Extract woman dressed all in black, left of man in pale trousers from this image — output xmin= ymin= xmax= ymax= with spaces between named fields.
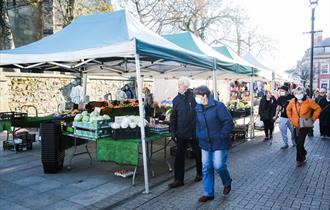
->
xmin=259 ymin=90 xmax=276 ymax=141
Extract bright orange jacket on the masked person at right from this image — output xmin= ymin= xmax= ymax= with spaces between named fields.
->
xmin=286 ymin=98 xmax=322 ymax=127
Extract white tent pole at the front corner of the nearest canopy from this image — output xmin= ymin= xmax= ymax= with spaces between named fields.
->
xmin=135 ymin=54 xmax=149 ymax=193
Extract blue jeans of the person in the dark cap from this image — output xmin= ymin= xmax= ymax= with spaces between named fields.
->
xmin=202 ymin=149 xmax=232 ymax=196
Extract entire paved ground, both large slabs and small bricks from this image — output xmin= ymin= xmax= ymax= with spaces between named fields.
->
xmin=0 ymin=127 xmax=330 ymax=210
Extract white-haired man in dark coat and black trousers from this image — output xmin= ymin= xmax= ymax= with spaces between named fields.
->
xmin=169 ymin=77 xmax=202 ymax=188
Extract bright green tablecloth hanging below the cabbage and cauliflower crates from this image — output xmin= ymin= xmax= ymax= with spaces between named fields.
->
xmin=96 ymin=133 xmax=170 ymax=165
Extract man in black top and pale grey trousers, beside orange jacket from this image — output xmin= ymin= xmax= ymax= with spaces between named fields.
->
xmin=274 ymin=86 xmax=296 ymax=149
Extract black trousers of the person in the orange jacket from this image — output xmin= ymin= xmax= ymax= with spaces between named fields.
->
xmin=294 ymin=128 xmax=310 ymax=161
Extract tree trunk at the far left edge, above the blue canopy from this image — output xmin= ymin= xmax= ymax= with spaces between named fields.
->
xmin=0 ymin=0 xmax=15 ymax=49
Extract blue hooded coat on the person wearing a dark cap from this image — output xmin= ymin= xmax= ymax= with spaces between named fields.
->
xmin=196 ymin=95 xmax=234 ymax=151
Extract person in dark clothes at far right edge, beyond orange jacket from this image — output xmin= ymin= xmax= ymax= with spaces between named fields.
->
xmin=319 ymin=89 xmax=330 ymax=137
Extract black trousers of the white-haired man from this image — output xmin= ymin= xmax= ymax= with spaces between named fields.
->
xmin=174 ymin=138 xmax=202 ymax=182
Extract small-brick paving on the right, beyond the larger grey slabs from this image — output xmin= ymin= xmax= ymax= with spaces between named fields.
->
xmin=109 ymin=129 xmax=330 ymax=210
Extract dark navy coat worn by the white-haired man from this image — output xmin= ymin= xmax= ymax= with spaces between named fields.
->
xmin=170 ymin=89 xmax=196 ymax=139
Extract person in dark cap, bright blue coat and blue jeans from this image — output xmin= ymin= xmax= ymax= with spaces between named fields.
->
xmin=194 ymin=86 xmax=234 ymax=202
